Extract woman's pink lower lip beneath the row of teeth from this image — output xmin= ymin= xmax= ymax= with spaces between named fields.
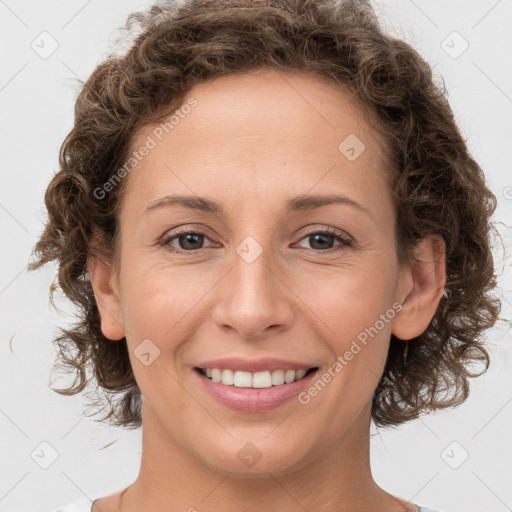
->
xmin=193 ymin=369 xmax=318 ymax=412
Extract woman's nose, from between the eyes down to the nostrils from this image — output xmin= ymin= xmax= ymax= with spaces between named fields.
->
xmin=213 ymin=240 xmax=294 ymax=340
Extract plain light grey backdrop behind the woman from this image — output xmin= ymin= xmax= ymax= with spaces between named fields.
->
xmin=0 ymin=0 xmax=512 ymax=512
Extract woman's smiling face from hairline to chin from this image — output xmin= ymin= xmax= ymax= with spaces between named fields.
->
xmin=92 ymin=71 xmax=424 ymax=474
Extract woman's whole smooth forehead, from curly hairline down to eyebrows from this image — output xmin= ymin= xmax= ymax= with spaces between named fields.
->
xmin=121 ymin=70 xmax=392 ymax=216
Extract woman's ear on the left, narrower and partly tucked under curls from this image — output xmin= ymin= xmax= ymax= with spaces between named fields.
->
xmin=87 ymin=235 xmax=125 ymax=340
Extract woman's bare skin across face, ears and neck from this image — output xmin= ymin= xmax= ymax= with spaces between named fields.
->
xmin=89 ymin=70 xmax=445 ymax=512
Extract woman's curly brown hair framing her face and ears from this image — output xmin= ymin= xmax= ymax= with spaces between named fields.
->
xmin=29 ymin=0 xmax=501 ymax=428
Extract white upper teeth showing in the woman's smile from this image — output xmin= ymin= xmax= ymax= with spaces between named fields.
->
xmin=201 ymin=368 xmax=307 ymax=388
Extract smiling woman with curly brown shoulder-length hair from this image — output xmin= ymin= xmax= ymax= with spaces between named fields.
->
xmin=32 ymin=0 xmax=499 ymax=512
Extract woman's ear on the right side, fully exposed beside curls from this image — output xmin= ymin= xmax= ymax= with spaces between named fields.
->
xmin=391 ymin=235 xmax=446 ymax=340
